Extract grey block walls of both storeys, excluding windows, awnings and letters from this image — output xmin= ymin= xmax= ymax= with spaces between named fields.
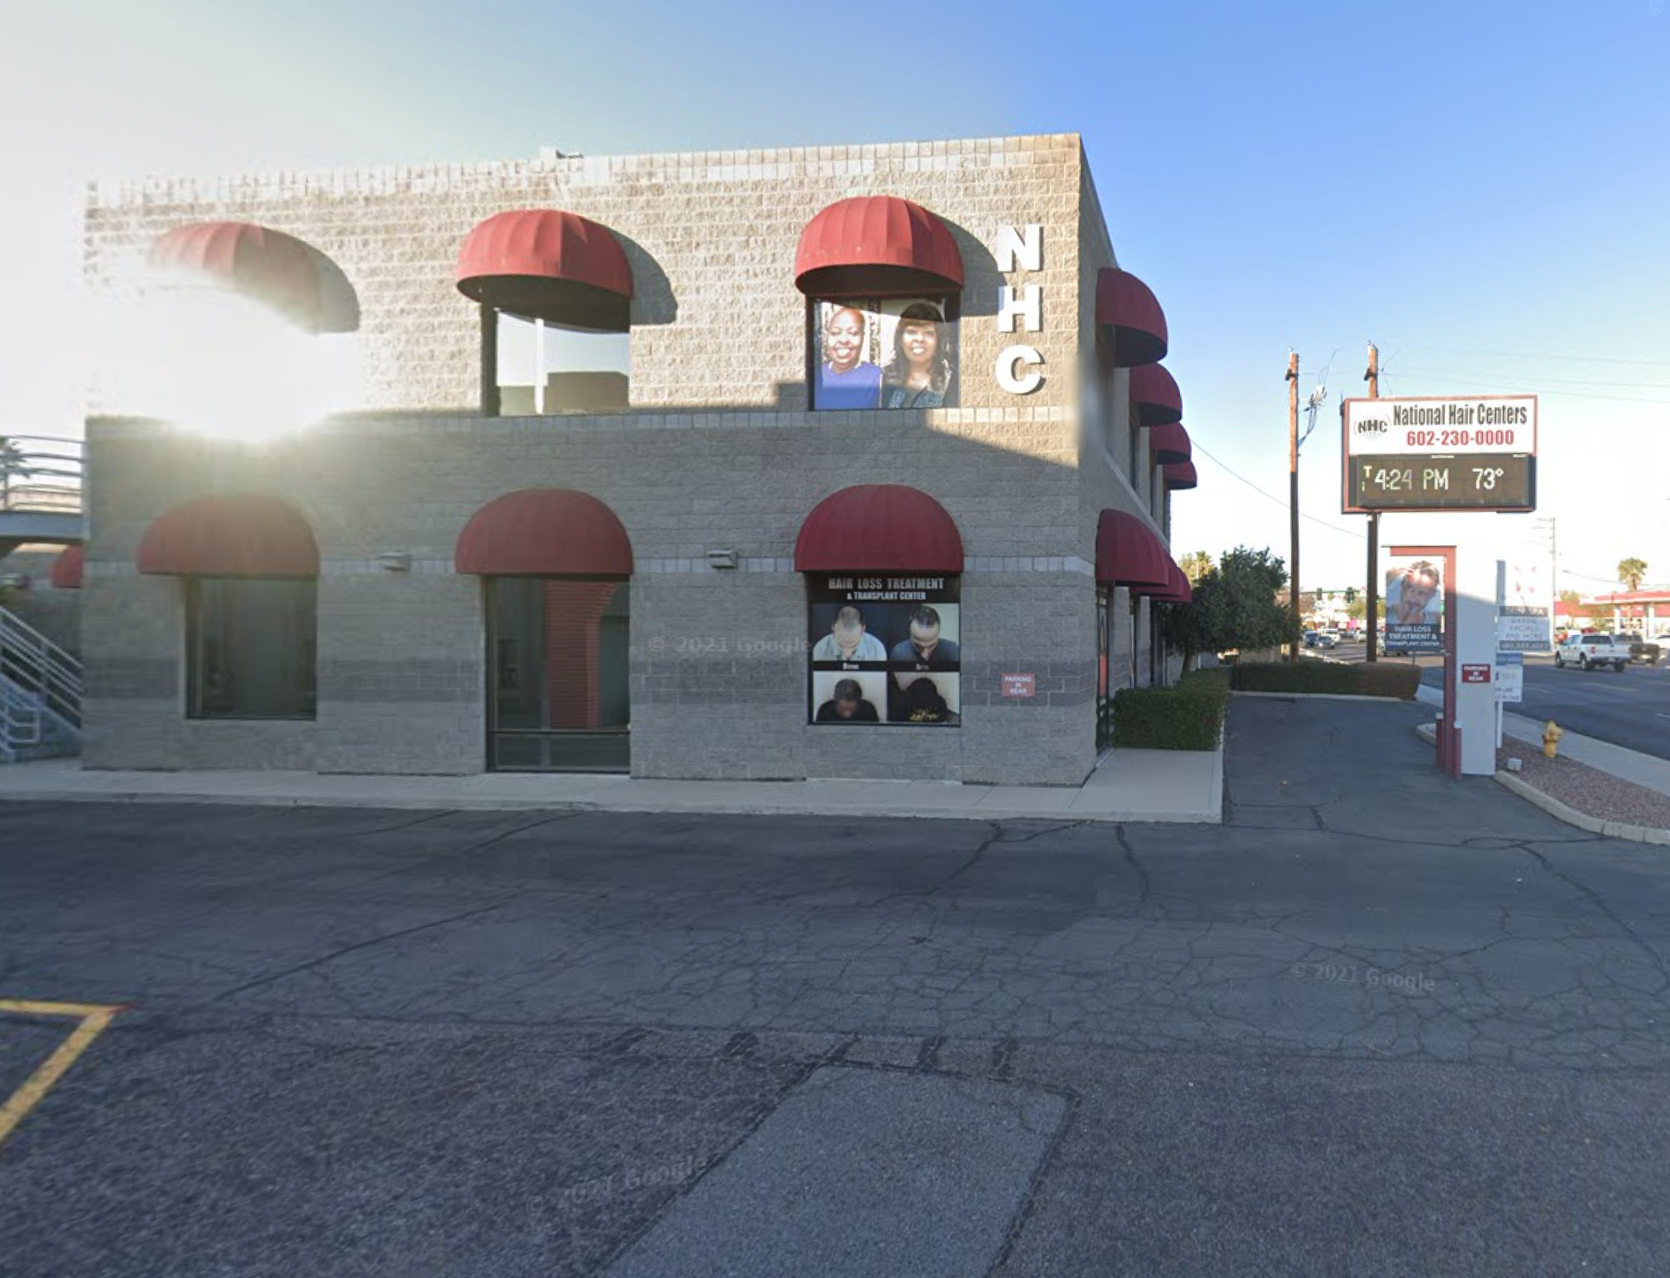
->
xmin=82 ymin=134 xmax=1164 ymax=784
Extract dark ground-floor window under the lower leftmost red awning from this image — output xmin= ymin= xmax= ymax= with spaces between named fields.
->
xmin=185 ymin=576 xmax=317 ymax=718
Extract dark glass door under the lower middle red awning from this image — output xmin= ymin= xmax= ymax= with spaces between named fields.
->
xmin=488 ymin=576 xmax=631 ymax=772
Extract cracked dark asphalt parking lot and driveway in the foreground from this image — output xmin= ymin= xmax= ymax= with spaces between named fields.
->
xmin=0 ymin=698 xmax=1670 ymax=1278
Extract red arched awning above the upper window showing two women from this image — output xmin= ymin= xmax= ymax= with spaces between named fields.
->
xmin=795 ymin=195 xmax=962 ymax=297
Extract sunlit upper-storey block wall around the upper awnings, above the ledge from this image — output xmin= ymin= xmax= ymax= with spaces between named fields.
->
xmin=87 ymin=134 xmax=1082 ymax=413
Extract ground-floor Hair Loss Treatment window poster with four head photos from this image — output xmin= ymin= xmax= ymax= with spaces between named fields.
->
xmin=807 ymin=575 xmax=962 ymax=727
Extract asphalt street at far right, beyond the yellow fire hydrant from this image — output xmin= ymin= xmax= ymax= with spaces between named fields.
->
xmin=1326 ymin=643 xmax=1670 ymax=758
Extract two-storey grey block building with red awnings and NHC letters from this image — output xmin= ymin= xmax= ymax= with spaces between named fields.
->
xmin=82 ymin=134 xmax=1194 ymax=785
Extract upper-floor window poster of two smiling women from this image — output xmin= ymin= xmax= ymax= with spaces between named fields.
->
xmin=808 ymin=297 xmax=957 ymax=411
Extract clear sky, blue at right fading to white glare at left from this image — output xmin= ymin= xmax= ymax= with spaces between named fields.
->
xmin=0 ymin=0 xmax=1670 ymax=593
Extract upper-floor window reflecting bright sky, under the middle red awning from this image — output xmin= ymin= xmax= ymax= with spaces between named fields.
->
xmin=494 ymin=307 xmax=631 ymax=418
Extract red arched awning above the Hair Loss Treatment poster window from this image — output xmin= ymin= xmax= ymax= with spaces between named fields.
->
xmin=795 ymin=484 xmax=962 ymax=573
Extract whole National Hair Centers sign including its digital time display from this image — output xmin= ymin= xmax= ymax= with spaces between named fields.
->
xmin=1339 ymin=394 xmax=1536 ymax=515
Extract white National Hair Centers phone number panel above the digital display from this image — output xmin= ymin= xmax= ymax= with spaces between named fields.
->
xmin=1344 ymin=394 xmax=1536 ymax=456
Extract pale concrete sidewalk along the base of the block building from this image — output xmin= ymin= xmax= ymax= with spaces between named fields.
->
xmin=0 ymin=745 xmax=1224 ymax=825
